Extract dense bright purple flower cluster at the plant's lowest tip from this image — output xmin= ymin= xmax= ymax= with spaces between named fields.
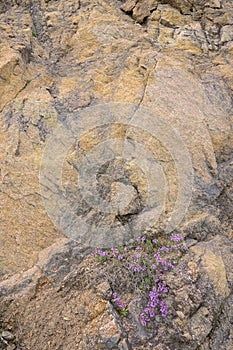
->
xmin=141 ymin=281 xmax=168 ymax=326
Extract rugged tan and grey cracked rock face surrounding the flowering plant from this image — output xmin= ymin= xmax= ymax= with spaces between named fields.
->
xmin=0 ymin=0 xmax=233 ymax=350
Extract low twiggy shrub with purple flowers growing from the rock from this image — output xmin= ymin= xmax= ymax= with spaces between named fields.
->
xmin=93 ymin=234 xmax=186 ymax=326
